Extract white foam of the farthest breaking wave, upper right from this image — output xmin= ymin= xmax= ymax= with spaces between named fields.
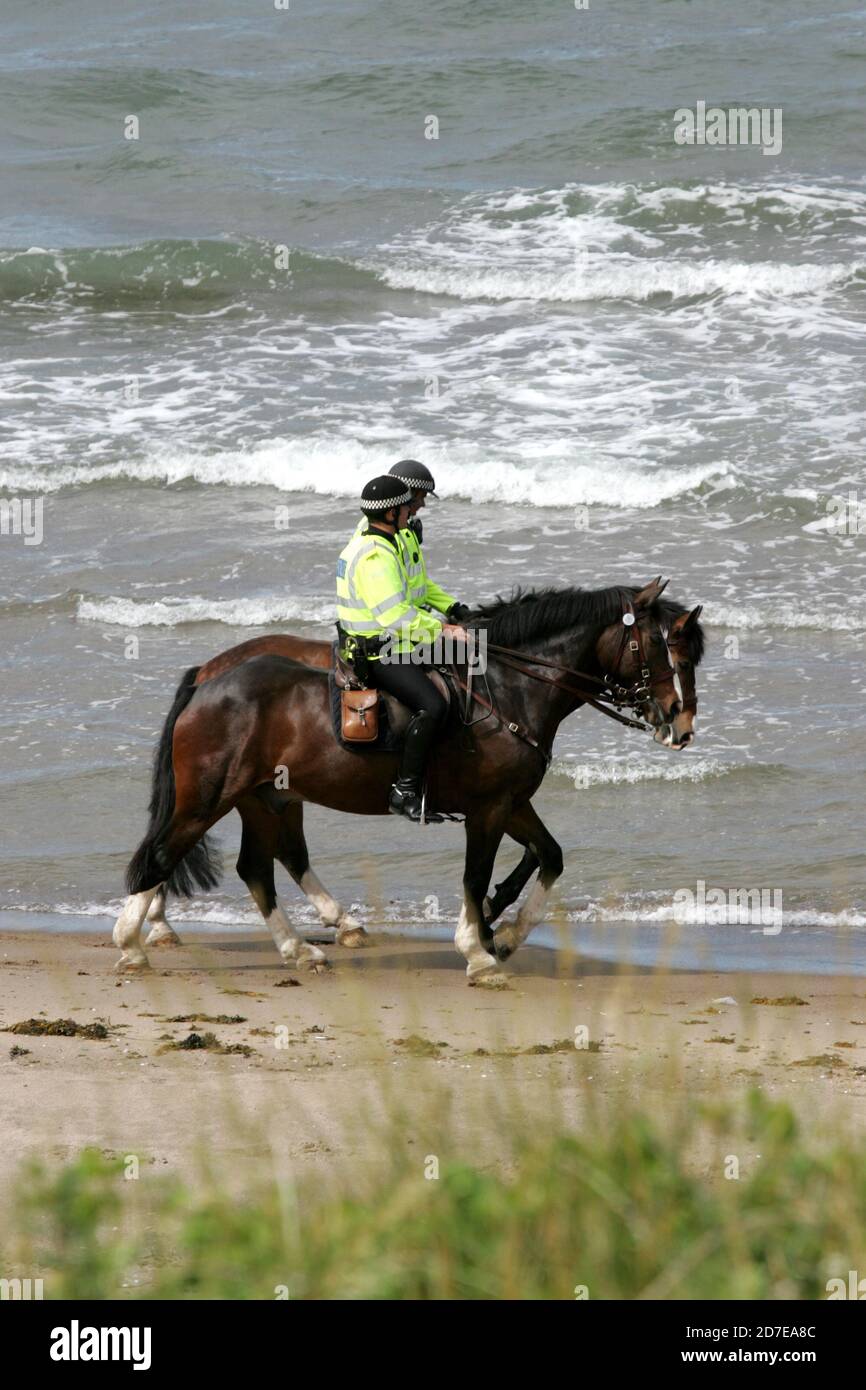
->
xmin=371 ymin=183 xmax=866 ymax=303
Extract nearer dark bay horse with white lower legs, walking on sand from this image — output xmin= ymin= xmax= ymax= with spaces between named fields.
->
xmin=115 ymin=581 xmax=702 ymax=981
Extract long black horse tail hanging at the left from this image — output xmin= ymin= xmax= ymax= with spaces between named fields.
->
xmin=126 ymin=666 xmax=221 ymax=898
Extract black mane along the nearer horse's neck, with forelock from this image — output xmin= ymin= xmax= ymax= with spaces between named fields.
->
xmin=467 ymin=584 xmax=703 ymax=666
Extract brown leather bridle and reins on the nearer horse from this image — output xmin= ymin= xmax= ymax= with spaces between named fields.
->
xmin=450 ymin=603 xmax=683 ymax=763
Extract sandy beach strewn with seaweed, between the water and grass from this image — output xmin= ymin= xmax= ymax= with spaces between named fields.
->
xmin=0 ymin=933 xmax=866 ymax=1188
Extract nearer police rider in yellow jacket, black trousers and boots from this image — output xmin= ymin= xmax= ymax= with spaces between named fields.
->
xmin=336 ymin=478 xmax=468 ymax=821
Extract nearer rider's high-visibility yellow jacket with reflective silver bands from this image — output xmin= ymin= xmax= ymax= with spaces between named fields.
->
xmin=336 ymin=527 xmax=450 ymax=652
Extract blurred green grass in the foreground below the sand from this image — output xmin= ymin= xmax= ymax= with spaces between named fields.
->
xmin=0 ymin=1091 xmax=866 ymax=1300
